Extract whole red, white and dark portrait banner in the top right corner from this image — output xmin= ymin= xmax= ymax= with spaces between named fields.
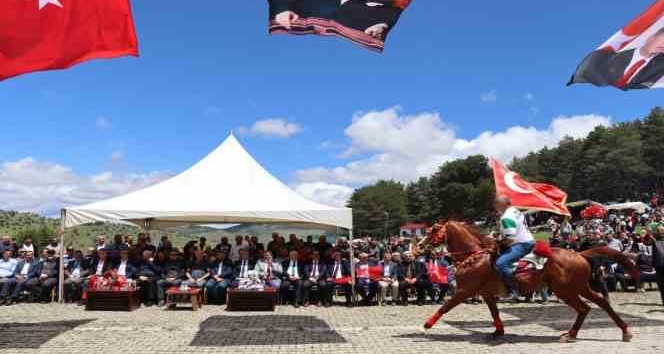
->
xmin=568 ymin=0 xmax=664 ymax=90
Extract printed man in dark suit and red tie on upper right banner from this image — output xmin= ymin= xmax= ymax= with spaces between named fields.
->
xmin=568 ymin=27 xmax=664 ymax=90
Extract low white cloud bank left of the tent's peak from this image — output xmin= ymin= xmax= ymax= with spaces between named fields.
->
xmin=0 ymin=157 xmax=167 ymax=216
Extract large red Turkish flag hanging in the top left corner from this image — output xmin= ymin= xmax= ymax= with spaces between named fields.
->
xmin=0 ymin=0 xmax=138 ymax=80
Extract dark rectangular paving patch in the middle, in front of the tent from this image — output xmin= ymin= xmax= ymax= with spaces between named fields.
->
xmin=190 ymin=315 xmax=346 ymax=347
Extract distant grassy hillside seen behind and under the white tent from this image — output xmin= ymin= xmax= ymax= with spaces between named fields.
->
xmin=0 ymin=210 xmax=336 ymax=249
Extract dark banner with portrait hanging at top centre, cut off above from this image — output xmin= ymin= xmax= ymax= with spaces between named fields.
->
xmin=268 ymin=0 xmax=412 ymax=52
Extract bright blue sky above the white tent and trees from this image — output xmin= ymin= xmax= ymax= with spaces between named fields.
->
xmin=0 ymin=0 xmax=662 ymax=212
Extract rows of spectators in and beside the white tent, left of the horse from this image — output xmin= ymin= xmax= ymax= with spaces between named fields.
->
xmin=0 ymin=233 xmax=454 ymax=307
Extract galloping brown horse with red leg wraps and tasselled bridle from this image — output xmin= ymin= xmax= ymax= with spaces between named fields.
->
xmin=415 ymin=221 xmax=639 ymax=342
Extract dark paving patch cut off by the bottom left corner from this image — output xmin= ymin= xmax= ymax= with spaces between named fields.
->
xmin=0 ymin=319 xmax=94 ymax=349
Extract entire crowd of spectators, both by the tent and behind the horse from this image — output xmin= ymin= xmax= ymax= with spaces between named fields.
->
xmin=0 ymin=210 xmax=664 ymax=307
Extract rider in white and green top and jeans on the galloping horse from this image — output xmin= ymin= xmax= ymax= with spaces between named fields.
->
xmin=495 ymin=195 xmax=535 ymax=301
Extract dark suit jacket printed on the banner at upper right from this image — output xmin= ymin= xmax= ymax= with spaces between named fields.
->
xmin=568 ymin=49 xmax=664 ymax=89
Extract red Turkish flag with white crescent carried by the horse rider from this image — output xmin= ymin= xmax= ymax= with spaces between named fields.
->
xmin=489 ymin=159 xmax=571 ymax=216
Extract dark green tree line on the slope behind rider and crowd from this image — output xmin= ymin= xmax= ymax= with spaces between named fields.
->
xmin=348 ymin=107 xmax=664 ymax=236
